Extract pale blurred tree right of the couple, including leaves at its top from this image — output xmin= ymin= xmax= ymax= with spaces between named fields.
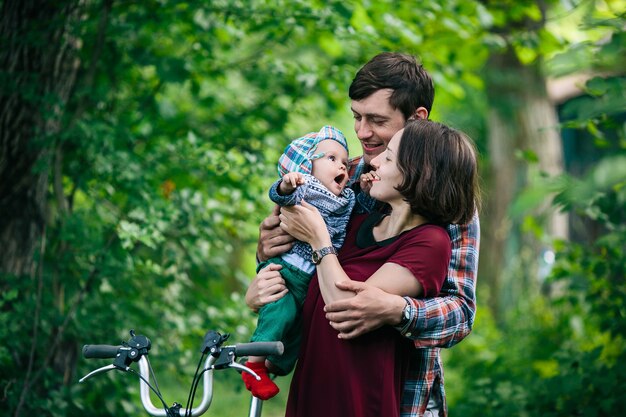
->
xmin=480 ymin=0 xmax=568 ymax=317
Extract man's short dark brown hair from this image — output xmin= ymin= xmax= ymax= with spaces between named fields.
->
xmin=348 ymin=52 xmax=435 ymax=120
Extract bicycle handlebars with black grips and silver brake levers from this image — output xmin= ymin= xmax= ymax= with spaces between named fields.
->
xmin=79 ymin=330 xmax=284 ymax=417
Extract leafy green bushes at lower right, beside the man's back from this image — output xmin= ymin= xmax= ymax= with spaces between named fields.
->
xmin=447 ymin=169 xmax=626 ymax=416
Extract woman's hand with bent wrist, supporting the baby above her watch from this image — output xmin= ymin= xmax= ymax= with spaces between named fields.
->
xmin=279 ymin=200 xmax=331 ymax=249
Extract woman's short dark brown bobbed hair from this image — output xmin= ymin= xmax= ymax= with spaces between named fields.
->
xmin=396 ymin=120 xmax=480 ymax=224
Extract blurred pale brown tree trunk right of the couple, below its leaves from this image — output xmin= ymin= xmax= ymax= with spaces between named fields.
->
xmin=479 ymin=49 xmax=567 ymax=318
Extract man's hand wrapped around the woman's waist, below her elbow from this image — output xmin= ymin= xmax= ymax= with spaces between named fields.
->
xmin=324 ymin=281 xmax=406 ymax=339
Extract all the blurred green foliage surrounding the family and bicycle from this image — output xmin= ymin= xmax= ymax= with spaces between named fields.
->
xmin=0 ymin=0 xmax=626 ymax=416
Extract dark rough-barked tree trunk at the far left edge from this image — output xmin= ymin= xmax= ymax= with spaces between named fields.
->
xmin=0 ymin=0 xmax=79 ymax=276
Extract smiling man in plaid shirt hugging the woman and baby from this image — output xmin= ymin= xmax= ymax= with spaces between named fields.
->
xmin=246 ymin=53 xmax=479 ymax=416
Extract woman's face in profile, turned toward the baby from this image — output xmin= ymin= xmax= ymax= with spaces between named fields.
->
xmin=370 ymin=129 xmax=404 ymax=203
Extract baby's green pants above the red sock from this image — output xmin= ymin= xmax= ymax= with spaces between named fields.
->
xmin=252 ymin=258 xmax=311 ymax=375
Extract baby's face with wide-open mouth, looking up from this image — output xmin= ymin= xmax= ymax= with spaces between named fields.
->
xmin=311 ymin=139 xmax=350 ymax=195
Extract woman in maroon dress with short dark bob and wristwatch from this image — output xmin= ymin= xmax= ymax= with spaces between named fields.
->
xmin=280 ymin=120 xmax=478 ymax=417
